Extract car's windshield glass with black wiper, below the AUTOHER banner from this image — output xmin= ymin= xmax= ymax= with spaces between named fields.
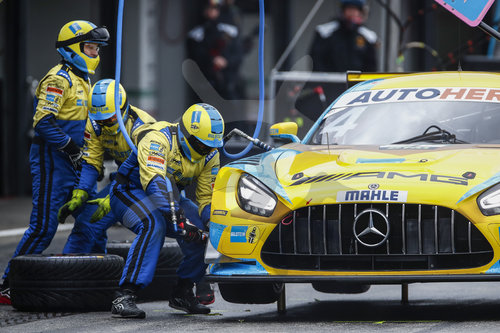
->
xmin=308 ymin=101 xmax=500 ymax=145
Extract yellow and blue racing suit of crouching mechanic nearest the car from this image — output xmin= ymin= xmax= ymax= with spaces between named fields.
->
xmin=110 ymin=122 xmax=220 ymax=287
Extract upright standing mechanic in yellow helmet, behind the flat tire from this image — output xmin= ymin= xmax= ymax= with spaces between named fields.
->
xmin=0 ymin=20 xmax=109 ymax=304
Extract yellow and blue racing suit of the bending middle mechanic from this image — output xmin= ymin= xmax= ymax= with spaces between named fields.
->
xmin=63 ymin=106 xmax=155 ymax=253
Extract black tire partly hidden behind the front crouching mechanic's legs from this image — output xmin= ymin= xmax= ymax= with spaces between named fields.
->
xmin=106 ymin=242 xmax=184 ymax=302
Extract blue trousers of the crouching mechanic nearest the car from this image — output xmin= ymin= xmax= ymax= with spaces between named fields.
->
xmin=110 ymin=181 xmax=207 ymax=287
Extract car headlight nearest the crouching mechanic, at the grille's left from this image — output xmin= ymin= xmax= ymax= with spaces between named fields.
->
xmin=238 ymin=173 xmax=278 ymax=216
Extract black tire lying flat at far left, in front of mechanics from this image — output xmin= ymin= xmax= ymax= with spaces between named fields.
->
xmin=9 ymin=254 xmax=124 ymax=312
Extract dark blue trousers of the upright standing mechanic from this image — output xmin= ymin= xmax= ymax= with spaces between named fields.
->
xmin=3 ymin=142 xmax=77 ymax=279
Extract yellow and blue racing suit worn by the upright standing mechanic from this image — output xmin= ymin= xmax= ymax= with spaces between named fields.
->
xmin=3 ymin=62 xmax=90 ymax=279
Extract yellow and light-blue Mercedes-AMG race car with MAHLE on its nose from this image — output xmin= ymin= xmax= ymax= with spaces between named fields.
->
xmin=206 ymin=71 xmax=500 ymax=303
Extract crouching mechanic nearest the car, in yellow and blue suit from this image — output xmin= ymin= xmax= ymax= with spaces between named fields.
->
xmin=110 ymin=104 xmax=224 ymax=318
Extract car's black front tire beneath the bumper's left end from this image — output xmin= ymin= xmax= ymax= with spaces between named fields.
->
xmin=219 ymin=283 xmax=284 ymax=304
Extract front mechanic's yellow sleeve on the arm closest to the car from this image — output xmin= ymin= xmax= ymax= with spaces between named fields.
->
xmin=196 ymin=150 xmax=220 ymax=216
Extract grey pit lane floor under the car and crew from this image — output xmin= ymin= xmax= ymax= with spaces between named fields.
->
xmin=0 ymin=198 xmax=500 ymax=333
